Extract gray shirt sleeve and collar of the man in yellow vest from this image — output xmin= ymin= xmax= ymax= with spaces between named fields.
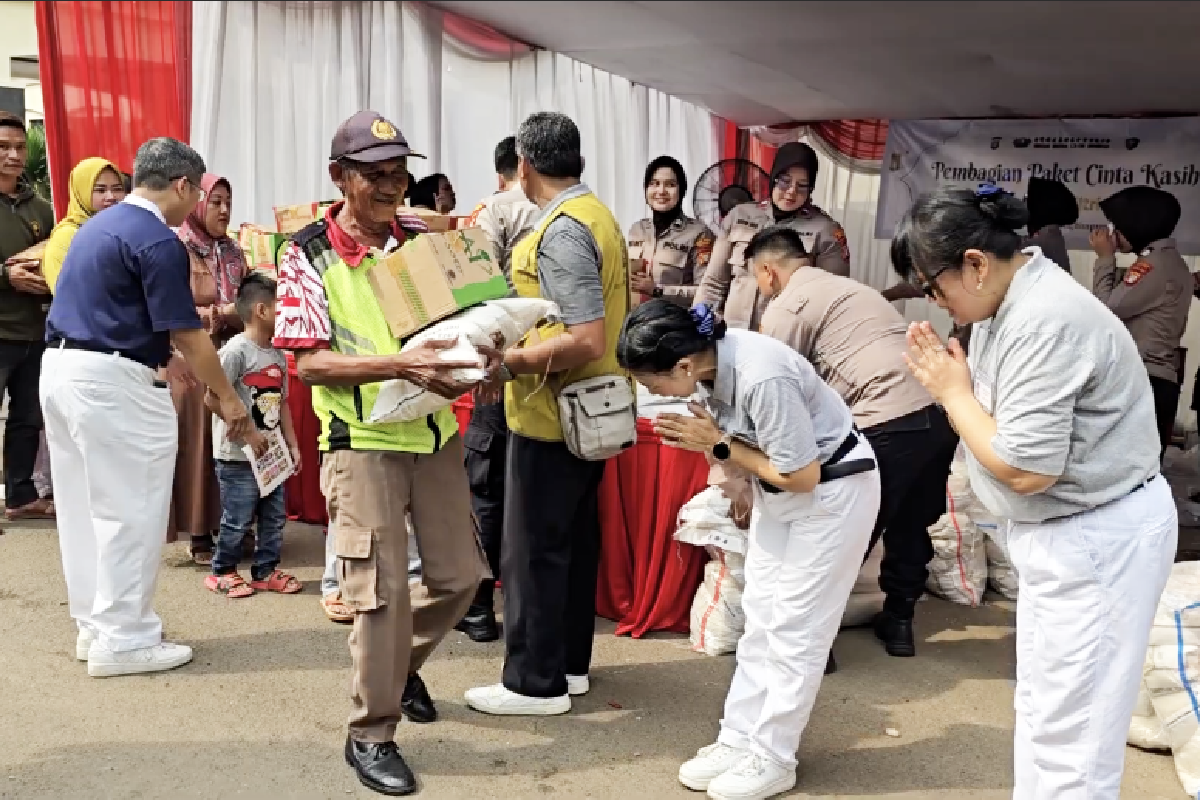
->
xmin=533 ymin=184 xmax=604 ymax=325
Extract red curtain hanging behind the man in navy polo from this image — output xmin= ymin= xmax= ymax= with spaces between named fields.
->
xmin=37 ymin=0 xmax=192 ymax=216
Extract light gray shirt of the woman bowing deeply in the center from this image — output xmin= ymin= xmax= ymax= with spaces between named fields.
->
xmin=704 ymin=329 xmax=853 ymax=475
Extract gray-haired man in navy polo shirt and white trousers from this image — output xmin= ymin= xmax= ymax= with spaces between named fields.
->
xmin=41 ymin=138 xmax=263 ymax=678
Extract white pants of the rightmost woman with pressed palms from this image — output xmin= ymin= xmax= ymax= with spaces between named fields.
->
xmin=1008 ymin=476 xmax=1178 ymax=800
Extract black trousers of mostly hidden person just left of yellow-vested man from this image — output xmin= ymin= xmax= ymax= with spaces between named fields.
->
xmin=462 ymin=401 xmax=509 ymax=599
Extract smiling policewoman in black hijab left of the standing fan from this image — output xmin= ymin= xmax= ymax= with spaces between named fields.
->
xmin=629 ymin=156 xmax=716 ymax=308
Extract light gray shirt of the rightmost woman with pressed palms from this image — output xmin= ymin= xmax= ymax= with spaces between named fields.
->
xmin=967 ymin=247 xmax=1159 ymax=522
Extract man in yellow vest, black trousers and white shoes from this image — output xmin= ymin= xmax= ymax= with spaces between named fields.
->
xmin=467 ymin=112 xmax=630 ymax=715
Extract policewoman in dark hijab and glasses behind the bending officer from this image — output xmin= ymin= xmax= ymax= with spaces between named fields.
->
xmin=696 ymin=142 xmax=850 ymax=330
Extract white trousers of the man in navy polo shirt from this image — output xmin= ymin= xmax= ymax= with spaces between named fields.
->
xmin=41 ymin=348 xmax=179 ymax=651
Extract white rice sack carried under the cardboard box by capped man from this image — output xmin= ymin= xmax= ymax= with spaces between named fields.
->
xmin=367 ymin=297 xmax=558 ymax=423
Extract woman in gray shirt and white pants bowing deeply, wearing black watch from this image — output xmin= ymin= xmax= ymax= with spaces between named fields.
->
xmin=617 ymin=300 xmax=880 ymax=800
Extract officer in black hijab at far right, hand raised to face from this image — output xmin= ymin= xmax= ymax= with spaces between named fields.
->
xmin=1091 ymin=186 xmax=1193 ymax=456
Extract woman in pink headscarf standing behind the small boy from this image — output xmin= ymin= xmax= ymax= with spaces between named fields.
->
xmin=167 ymin=173 xmax=250 ymax=565
